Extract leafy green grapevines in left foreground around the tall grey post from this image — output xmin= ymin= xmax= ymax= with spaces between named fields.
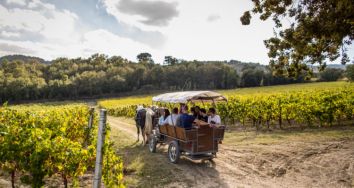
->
xmin=0 ymin=104 xmax=123 ymax=187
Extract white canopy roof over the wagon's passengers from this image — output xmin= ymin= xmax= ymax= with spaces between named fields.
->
xmin=152 ymin=91 xmax=227 ymax=103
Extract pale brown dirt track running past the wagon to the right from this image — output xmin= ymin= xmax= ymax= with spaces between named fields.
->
xmin=108 ymin=117 xmax=354 ymax=188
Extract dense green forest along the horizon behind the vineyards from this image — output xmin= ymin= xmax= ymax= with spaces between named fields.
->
xmin=0 ymin=53 xmax=344 ymax=103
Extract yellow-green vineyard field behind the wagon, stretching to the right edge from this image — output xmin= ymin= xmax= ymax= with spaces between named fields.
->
xmin=99 ymin=82 xmax=354 ymax=129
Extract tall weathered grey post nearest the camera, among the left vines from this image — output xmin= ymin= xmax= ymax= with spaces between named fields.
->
xmin=93 ymin=109 xmax=107 ymax=188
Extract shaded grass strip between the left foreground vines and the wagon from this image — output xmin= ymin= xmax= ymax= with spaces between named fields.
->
xmin=111 ymin=123 xmax=178 ymax=187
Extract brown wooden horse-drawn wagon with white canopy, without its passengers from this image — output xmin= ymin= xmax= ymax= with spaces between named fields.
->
xmin=149 ymin=91 xmax=227 ymax=163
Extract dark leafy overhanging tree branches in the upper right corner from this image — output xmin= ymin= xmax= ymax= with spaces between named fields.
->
xmin=240 ymin=0 xmax=354 ymax=77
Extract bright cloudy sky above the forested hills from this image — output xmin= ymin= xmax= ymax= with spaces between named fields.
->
xmin=0 ymin=0 xmax=354 ymax=64
